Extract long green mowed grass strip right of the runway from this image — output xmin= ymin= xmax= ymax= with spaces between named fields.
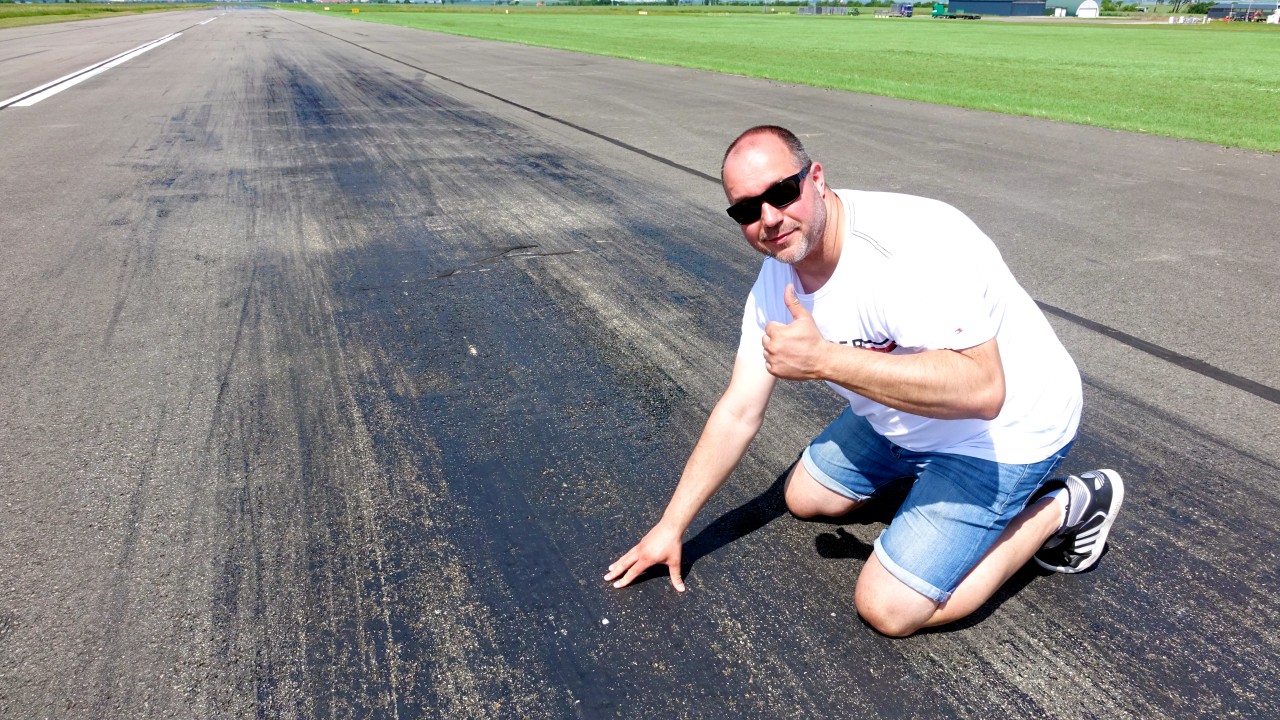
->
xmin=285 ymin=5 xmax=1280 ymax=152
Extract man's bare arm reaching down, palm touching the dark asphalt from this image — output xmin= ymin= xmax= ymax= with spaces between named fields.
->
xmin=604 ymin=359 xmax=776 ymax=592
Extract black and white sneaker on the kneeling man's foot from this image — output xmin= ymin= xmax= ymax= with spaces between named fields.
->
xmin=1033 ymin=470 xmax=1124 ymax=573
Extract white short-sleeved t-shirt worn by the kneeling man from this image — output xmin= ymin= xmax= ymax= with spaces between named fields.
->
xmin=737 ymin=190 xmax=1083 ymax=464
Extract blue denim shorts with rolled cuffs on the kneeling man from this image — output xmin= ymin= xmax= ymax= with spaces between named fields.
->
xmin=801 ymin=409 xmax=1074 ymax=602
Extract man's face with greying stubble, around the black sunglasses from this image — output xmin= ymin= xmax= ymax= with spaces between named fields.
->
xmin=723 ymin=135 xmax=827 ymax=265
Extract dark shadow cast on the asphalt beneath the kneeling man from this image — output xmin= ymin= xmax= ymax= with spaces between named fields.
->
xmin=624 ymin=468 xmax=1052 ymax=634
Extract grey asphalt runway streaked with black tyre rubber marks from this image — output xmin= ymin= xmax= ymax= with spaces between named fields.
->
xmin=0 ymin=10 xmax=1280 ymax=719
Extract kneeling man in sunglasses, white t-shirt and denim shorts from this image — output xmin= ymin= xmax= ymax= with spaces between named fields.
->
xmin=604 ymin=126 xmax=1124 ymax=637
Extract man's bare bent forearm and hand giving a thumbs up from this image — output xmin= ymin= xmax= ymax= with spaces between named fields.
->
xmin=763 ymin=287 xmax=1005 ymax=420
